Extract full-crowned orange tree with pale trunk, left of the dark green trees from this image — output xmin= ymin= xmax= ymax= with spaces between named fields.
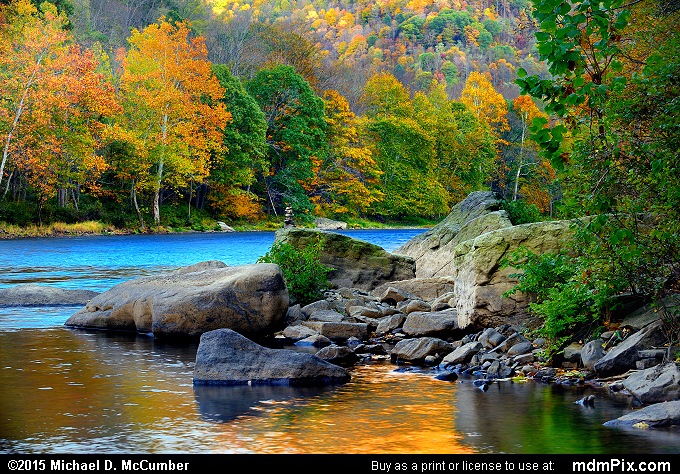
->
xmin=120 ymin=19 xmax=231 ymax=224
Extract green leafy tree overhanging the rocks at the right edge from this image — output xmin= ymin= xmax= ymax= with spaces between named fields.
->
xmin=517 ymin=0 xmax=680 ymax=344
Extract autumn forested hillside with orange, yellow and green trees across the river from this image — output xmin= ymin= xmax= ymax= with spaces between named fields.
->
xmin=0 ymin=0 xmax=677 ymax=244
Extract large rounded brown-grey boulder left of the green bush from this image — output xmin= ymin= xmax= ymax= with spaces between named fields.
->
xmin=66 ymin=261 xmax=289 ymax=337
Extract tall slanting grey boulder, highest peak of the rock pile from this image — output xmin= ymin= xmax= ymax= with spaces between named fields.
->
xmin=396 ymin=191 xmax=512 ymax=278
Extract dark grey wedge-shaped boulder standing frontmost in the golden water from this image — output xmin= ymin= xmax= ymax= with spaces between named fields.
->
xmin=194 ymin=329 xmax=350 ymax=385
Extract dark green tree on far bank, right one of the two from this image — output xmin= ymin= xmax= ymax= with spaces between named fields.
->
xmin=246 ymin=66 xmax=327 ymax=215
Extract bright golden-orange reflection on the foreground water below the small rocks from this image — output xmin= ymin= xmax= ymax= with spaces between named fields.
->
xmin=214 ymin=364 xmax=474 ymax=454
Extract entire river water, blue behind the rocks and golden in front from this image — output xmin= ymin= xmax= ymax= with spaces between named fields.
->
xmin=0 ymin=229 xmax=680 ymax=454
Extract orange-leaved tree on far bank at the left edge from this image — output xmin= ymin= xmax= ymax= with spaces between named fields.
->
xmin=0 ymin=0 xmax=119 ymax=221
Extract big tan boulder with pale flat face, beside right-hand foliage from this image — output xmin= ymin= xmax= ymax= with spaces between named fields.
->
xmin=453 ymin=221 xmax=574 ymax=329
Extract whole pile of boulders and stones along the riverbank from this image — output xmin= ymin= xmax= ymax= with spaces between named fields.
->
xmin=54 ymin=192 xmax=680 ymax=430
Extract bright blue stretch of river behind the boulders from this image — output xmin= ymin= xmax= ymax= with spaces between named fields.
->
xmin=0 ymin=229 xmax=424 ymax=291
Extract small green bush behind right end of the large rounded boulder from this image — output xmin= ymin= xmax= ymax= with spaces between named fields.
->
xmin=257 ymin=239 xmax=331 ymax=305
